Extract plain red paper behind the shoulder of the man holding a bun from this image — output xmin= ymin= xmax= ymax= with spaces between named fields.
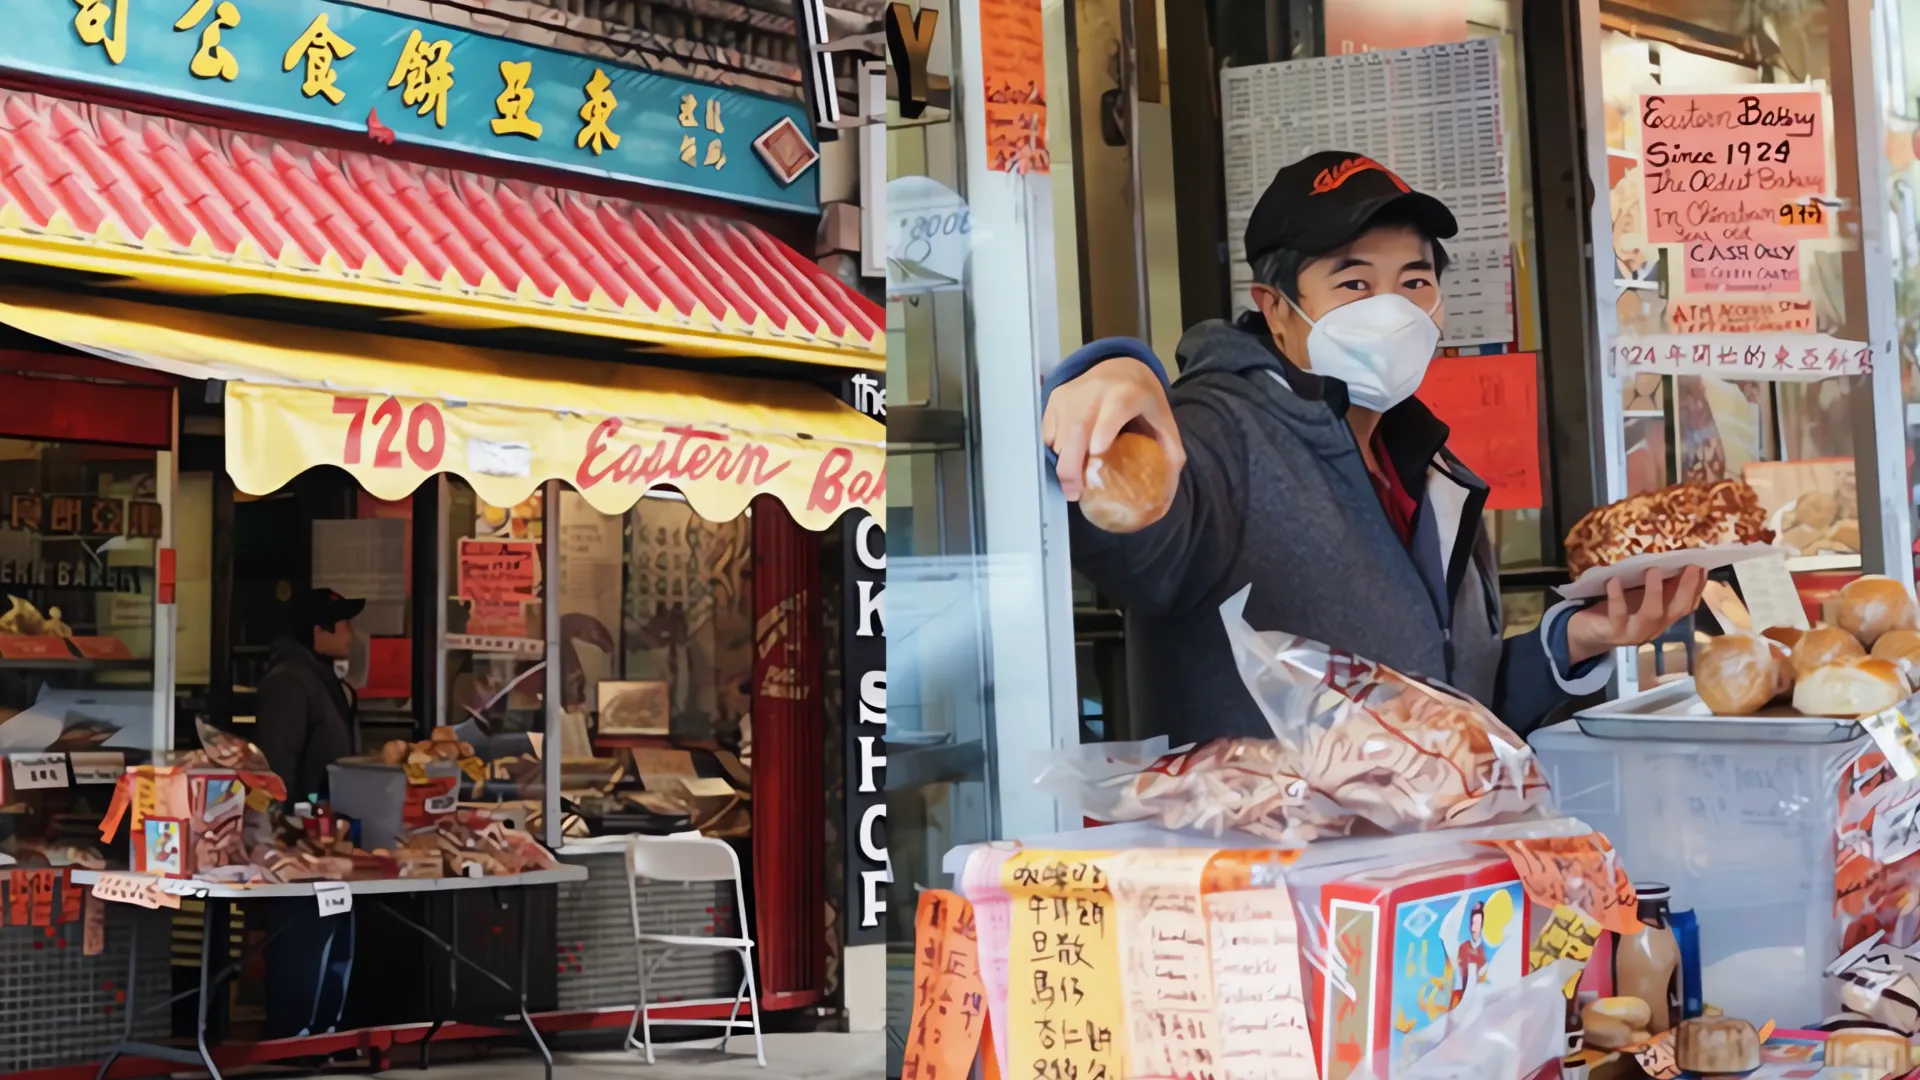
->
xmin=1419 ymin=352 xmax=1540 ymax=509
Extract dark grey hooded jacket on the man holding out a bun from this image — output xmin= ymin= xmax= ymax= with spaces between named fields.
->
xmin=1048 ymin=319 xmax=1592 ymax=742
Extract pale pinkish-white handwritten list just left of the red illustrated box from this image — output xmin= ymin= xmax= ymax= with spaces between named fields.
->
xmin=1206 ymin=884 xmax=1317 ymax=1080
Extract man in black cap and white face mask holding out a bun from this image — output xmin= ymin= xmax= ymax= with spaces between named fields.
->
xmin=1043 ymin=152 xmax=1705 ymax=742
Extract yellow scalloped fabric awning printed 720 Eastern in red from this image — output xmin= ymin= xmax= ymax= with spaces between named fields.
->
xmin=0 ymin=290 xmax=887 ymax=530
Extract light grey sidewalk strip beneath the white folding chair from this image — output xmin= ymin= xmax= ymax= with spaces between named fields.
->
xmin=374 ymin=1032 xmax=887 ymax=1080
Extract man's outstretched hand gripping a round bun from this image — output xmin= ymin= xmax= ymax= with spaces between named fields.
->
xmin=1041 ymin=357 xmax=1187 ymax=505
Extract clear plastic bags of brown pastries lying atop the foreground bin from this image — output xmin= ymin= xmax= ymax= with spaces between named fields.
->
xmin=1039 ymin=590 xmax=1551 ymax=844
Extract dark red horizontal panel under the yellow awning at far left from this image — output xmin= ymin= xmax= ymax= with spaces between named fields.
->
xmin=0 ymin=365 xmax=173 ymax=441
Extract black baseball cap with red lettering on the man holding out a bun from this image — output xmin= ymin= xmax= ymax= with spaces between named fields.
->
xmin=1246 ymin=150 xmax=1459 ymax=261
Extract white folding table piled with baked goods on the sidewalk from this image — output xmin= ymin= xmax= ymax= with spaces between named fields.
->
xmin=71 ymin=724 xmax=588 ymax=1078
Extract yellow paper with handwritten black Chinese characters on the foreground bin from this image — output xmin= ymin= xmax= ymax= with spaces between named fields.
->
xmin=1000 ymin=851 xmax=1131 ymax=1080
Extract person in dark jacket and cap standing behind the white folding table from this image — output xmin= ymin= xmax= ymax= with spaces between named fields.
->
xmin=253 ymin=588 xmax=367 ymax=1040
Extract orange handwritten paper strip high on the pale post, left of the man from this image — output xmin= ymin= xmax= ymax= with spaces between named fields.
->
xmin=979 ymin=0 xmax=1052 ymax=173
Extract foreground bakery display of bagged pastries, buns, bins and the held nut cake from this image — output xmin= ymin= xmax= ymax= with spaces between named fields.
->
xmin=904 ymin=484 xmax=1920 ymax=1080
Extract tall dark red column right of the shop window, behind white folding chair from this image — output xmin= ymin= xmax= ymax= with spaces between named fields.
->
xmin=753 ymin=496 xmax=828 ymax=1001
